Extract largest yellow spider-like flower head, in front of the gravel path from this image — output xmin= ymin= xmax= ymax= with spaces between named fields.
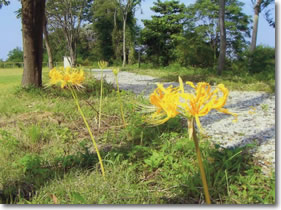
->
xmin=146 ymin=77 xmax=237 ymax=129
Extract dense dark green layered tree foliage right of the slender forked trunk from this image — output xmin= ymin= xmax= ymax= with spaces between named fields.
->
xmin=141 ymin=0 xmax=185 ymax=66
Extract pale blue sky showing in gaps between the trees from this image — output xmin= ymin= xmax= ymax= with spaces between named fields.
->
xmin=0 ymin=0 xmax=276 ymax=60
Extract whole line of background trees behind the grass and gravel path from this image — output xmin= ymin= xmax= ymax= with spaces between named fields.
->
xmin=0 ymin=0 xmax=275 ymax=87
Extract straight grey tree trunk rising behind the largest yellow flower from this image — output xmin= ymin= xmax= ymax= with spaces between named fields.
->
xmin=218 ymin=0 xmax=226 ymax=75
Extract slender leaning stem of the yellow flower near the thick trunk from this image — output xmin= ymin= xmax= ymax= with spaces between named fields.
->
xmin=70 ymin=86 xmax=105 ymax=179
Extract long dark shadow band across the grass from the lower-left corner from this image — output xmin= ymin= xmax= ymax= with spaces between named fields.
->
xmin=0 ymin=116 xmax=184 ymax=204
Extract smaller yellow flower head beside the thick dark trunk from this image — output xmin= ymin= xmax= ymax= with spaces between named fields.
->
xmin=49 ymin=67 xmax=85 ymax=88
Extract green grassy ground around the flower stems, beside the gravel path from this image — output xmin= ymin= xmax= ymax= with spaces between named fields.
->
xmin=0 ymin=69 xmax=275 ymax=204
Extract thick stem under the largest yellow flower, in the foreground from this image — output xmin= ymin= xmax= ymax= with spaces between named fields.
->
xmin=188 ymin=118 xmax=211 ymax=204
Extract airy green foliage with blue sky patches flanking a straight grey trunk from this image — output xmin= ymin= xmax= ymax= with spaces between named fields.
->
xmin=187 ymin=0 xmax=250 ymax=62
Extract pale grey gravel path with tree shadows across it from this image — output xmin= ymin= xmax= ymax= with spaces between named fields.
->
xmin=93 ymin=70 xmax=275 ymax=174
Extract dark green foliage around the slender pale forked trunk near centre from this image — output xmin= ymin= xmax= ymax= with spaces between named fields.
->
xmin=92 ymin=0 xmax=136 ymax=63
